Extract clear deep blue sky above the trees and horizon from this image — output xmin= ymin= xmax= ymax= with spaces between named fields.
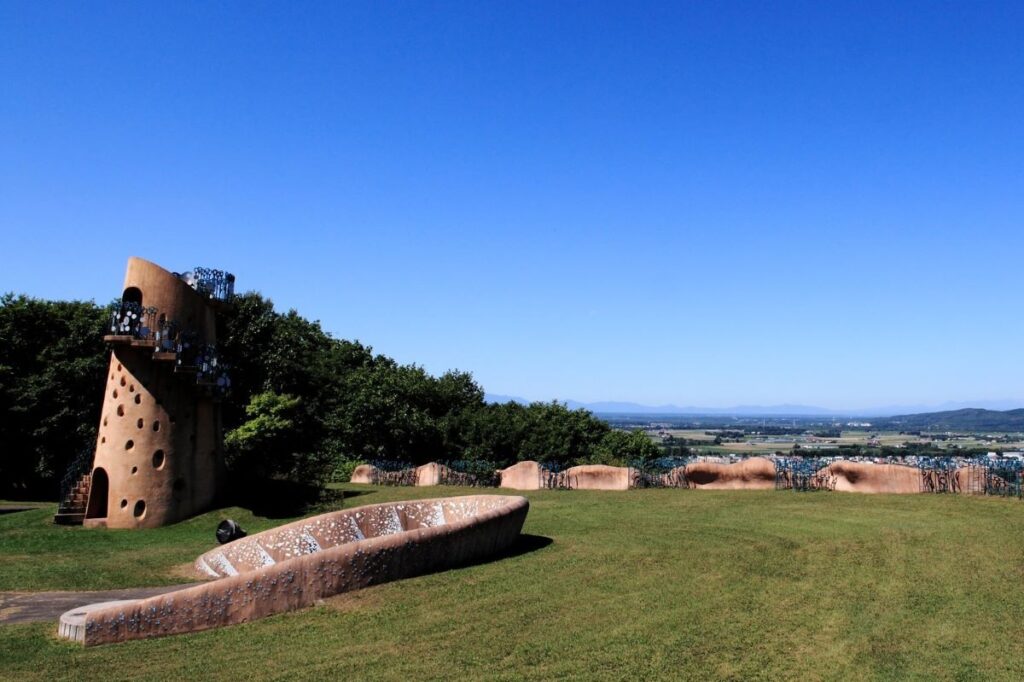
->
xmin=0 ymin=0 xmax=1024 ymax=409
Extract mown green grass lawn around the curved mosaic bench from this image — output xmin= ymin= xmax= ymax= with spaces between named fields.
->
xmin=0 ymin=486 xmax=1024 ymax=680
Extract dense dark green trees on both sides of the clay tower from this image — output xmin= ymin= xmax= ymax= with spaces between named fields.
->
xmin=0 ymin=293 xmax=658 ymax=494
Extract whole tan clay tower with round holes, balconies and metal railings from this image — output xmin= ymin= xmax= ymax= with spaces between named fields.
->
xmin=84 ymin=258 xmax=234 ymax=528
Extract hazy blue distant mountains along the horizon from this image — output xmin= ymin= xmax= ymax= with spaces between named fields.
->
xmin=484 ymin=393 xmax=1024 ymax=419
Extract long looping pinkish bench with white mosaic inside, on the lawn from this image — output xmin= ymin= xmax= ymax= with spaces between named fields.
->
xmin=58 ymin=495 xmax=529 ymax=646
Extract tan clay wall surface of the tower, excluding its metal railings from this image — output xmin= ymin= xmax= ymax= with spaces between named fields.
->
xmin=85 ymin=258 xmax=223 ymax=528
